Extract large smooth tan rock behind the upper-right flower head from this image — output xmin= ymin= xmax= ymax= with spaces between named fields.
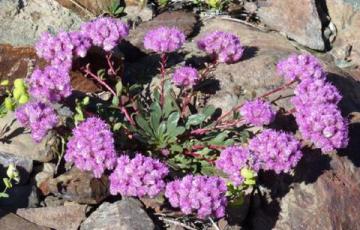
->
xmin=184 ymin=19 xmax=296 ymax=111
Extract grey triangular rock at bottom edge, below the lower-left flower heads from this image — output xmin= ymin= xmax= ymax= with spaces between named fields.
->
xmin=80 ymin=198 xmax=155 ymax=230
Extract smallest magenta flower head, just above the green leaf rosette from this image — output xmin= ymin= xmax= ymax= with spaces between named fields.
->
xmin=172 ymin=66 xmax=199 ymax=87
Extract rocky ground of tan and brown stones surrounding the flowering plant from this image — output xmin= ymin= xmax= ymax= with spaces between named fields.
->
xmin=0 ymin=0 xmax=360 ymax=230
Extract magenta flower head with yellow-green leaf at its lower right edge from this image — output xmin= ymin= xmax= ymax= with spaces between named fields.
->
xmin=215 ymin=146 xmax=254 ymax=186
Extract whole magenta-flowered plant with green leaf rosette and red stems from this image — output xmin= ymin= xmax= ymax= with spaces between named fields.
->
xmin=4 ymin=18 xmax=348 ymax=219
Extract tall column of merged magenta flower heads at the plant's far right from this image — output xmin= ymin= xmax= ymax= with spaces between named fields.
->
xmin=278 ymin=55 xmax=349 ymax=153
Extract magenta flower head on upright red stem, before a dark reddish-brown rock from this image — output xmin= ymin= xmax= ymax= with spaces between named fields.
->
xmin=144 ymin=26 xmax=186 ymax=53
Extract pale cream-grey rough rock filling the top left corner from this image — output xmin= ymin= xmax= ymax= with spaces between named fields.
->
xmin=0 ymin=0 xmax=82 ymax=46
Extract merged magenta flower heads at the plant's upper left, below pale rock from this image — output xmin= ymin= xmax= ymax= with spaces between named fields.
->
xmin=35 ymin=17 xmax=129 ymax=70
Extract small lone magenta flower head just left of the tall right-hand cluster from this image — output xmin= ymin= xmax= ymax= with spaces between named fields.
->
xmin=240 ymin=99 xmax=276 ymax=126
